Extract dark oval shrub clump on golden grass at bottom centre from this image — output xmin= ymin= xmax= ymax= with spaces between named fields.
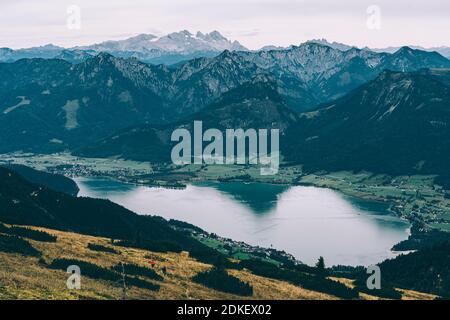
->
xmin=192 ymin=268 xmax=253 ymax=296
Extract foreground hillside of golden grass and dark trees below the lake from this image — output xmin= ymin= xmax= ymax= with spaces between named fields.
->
xmin=0 ymin=168 xmax=442 ymax=299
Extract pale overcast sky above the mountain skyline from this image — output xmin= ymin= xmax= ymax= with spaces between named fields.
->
xmin=0 ymin=0 xmax=450 ymax=49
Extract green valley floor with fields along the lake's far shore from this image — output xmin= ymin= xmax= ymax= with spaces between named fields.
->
xmin=0 ymin=153 xmax=450 ymax=253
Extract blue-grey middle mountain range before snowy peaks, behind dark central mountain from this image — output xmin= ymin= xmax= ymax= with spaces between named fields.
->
xmin=0 ymin=43 xmax=450 ymax=152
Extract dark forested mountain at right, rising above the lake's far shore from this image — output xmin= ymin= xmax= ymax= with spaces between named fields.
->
xmin=285 ymin=69 xmax=450 ymax=176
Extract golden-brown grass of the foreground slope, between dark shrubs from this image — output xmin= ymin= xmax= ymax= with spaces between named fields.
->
xmin=0 ymin=227 xmax=433 ymax=300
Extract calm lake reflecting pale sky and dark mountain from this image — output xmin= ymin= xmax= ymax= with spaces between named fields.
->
xmin=76 ymin=178 xmax=410 ymax=266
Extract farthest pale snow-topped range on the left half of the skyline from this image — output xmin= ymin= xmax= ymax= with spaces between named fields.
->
xmin=0 ymin=30 xmax=248 ymax=64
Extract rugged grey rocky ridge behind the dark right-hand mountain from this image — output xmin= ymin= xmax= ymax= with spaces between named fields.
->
xmin=234 ymin=42 xmax=450 ymax=111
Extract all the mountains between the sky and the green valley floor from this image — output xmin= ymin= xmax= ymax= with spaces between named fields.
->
xmin=0 ymin=32 xmax=450 ymax=179
